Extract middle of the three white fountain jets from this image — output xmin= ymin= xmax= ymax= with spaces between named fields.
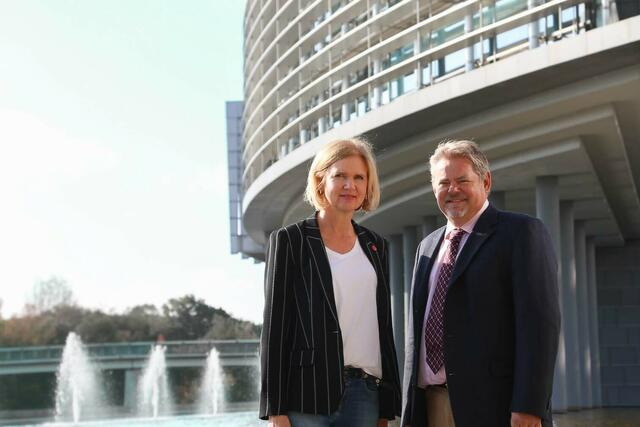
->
xmin=138 ymin=345 xmax=173 ymax=418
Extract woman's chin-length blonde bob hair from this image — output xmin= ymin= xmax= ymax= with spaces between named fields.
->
xmin=304 ymin=138 xmax=380 ymax=212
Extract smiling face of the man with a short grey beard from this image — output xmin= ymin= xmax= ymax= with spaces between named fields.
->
xmin=431 ymin=157 xmax=491 ymax=227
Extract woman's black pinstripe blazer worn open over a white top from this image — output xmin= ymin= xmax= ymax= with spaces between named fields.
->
xmin=260 ymin=215 xmax=401 ymax=419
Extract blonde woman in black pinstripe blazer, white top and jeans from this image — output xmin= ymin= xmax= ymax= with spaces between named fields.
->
xmin=260 ymin=139 xmax=400 ymax=427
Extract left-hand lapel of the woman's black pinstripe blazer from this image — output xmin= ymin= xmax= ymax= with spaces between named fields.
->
xmin=303 ymin=214 xmax=338 ymax=323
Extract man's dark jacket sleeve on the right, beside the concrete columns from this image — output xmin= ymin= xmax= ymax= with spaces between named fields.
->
xmin=511 ymin=218 xmax=560 ymax=417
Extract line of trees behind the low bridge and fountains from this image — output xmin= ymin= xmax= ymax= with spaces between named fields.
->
xmin=0 ymin=277 xmax=261 ymax=347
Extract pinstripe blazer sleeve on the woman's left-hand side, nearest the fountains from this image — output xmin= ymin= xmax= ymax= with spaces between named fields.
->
xmin=259 ymin=229 xmax=295 ymax=420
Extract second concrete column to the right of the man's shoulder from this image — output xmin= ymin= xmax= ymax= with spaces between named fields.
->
xmin=560 ymin=201 xmax=582 ymax=410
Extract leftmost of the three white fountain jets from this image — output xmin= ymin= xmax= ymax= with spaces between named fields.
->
xmin=55 ymin=332 xmax=104 ymax=423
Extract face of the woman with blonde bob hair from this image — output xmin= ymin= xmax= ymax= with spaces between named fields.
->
xmin=323 ymin=155 xmax=368 ymax=213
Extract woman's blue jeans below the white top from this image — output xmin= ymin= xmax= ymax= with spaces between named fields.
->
xmin=289 ymin=377 xmax=378 ymax=427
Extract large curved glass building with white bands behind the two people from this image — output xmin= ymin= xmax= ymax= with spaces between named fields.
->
xmin=227 ymin=0 xmax=640 ymax=410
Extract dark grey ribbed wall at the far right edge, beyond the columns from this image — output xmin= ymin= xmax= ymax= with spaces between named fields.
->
xmin=596 ymin=240 xmax=640 ymax=406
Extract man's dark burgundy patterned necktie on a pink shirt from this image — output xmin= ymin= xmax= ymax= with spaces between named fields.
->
xmin=424 ymin=228 xmax=465 ymax=374
